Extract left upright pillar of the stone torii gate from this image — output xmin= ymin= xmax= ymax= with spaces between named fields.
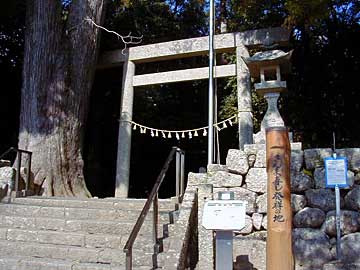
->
xmin=115 ymin=61 xmax=135 ymax=198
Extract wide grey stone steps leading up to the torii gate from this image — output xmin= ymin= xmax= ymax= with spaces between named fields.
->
xmin=0 ymin=197 xmax=175 ymax=270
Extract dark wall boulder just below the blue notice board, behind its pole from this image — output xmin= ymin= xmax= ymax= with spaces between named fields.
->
xmin=305 ymin=189 xmax=344 ymax=212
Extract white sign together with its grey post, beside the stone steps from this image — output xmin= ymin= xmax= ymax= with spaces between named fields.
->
xmin=202 ymin=192 xmax=246 ymax=270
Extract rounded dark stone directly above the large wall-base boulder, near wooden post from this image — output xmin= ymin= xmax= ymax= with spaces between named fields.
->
xmin=293 ymin=207 xmax=325 ymax=228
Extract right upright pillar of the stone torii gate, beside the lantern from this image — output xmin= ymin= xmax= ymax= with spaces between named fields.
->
xmin=236 ymin=44 xmax=253 ymax=150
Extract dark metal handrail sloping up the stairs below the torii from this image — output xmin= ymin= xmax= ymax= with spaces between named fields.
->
xmin=124 ymin=147 xmax=185 ymax=270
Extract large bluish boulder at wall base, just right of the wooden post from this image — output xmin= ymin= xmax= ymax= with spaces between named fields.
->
xmin=292 ymin=228 xmax=334 ymax=269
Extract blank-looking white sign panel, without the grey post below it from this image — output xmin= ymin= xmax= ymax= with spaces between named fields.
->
xmin=202 ymin=200 xmax=246 ymax=231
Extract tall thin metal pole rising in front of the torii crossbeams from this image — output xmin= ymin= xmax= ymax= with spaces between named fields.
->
xmin=208 ymin=0 xmax=214 ymax=164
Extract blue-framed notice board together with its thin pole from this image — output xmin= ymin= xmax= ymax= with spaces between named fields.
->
xmin=324 ymin=151 xmax=348 ymax=260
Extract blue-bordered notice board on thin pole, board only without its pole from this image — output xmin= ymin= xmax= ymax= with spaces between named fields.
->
xmin=324 ymin=157 xmax=348 ymax=188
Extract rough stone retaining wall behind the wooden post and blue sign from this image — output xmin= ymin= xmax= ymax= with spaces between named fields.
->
xmin=188 ymin=147 xmax=360 ymax=270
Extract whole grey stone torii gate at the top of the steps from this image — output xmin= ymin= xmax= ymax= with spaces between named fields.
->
xmin=98 ymin=28 xmax=289 ymax=198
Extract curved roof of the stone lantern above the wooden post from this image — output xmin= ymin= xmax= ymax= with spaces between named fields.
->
xmin=243 ymin=50 xmax=293 ymax=78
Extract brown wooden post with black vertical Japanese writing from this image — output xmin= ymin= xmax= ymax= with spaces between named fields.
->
xmin=266 ymin=127 xmax=294 ymax=270
